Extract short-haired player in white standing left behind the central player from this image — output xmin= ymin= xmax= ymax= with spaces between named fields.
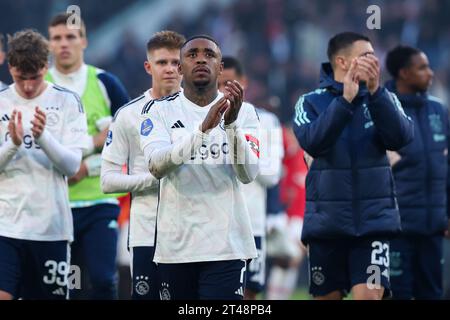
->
xmin=101 ymin=31 xmax=186 ymax=300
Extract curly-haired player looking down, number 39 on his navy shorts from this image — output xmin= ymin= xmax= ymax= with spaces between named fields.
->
xmin=0 ymin=30 xmax=87 ymax=299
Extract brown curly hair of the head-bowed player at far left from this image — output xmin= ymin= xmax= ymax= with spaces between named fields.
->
xmin=7 ymin=29 xmax=49 ymax=74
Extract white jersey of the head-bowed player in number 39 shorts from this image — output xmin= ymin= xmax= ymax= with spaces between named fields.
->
xmin=0 ymin=83 xmax=88 ymax=241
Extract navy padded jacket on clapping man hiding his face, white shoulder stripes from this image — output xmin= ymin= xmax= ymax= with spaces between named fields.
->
xmin=294 ymin=63 xmax=414 ymax=243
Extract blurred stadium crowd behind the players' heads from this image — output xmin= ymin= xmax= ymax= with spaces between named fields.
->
xmin=0 ymin=0 xmax=450 ymax=294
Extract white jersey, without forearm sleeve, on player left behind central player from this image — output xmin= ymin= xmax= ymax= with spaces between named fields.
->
xmin=102 ymin=91 xmax=158 ymax=248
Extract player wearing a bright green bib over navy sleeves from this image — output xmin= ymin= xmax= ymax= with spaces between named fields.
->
xmin=46 ymin=13 xmax=129 ymax=299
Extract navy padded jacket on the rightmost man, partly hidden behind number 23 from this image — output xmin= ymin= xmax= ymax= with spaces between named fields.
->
xmin=386 ymin=81 xmax=450 ymax=235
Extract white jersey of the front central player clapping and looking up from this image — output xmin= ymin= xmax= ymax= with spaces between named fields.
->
xmin=140 ymin=92 xmax=259 ymax=263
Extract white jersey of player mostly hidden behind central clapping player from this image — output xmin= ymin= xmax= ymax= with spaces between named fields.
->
xmin=242 ymin=108 xmax=284 ymax=236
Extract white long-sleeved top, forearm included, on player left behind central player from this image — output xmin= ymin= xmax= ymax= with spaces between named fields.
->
xmin=101 ymin=91 xmax=159 ymax=248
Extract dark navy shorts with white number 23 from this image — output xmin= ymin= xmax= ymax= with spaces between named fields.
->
xmin=308 ymin=237 xmax=390 ymax=296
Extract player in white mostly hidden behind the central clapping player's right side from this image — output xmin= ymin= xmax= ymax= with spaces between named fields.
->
xmin=219 ymin=57 xmax=283 ymax=300
